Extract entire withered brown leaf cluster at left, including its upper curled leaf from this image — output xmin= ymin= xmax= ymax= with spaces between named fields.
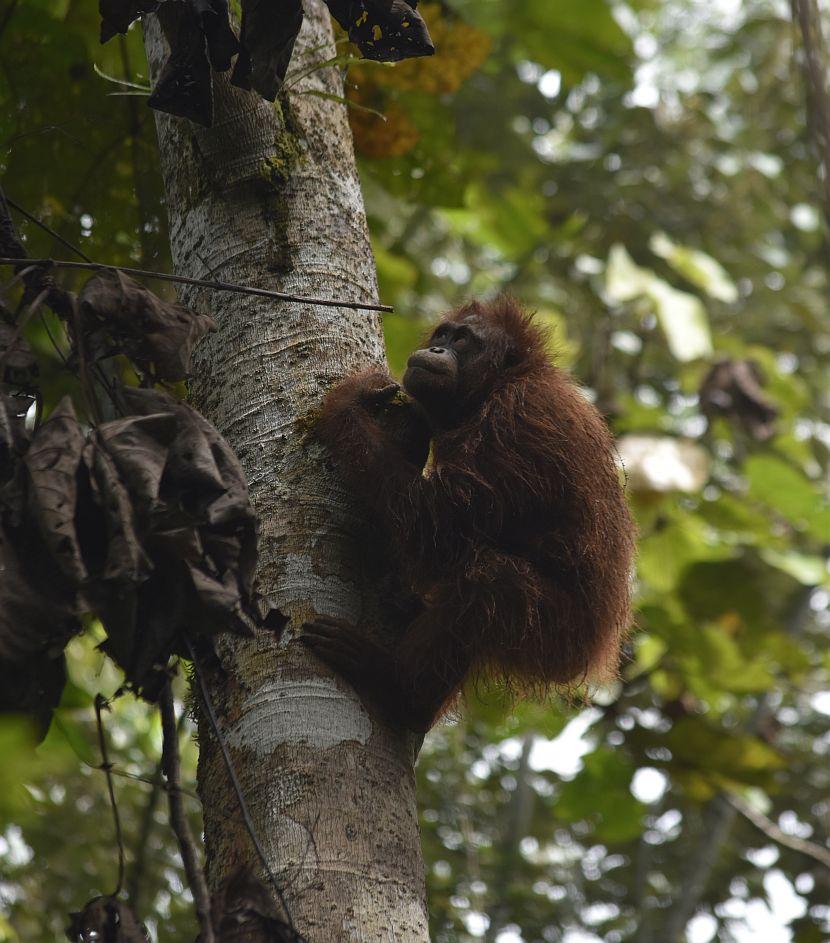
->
xmin=0 ymin=271 xmax=256 ymax=735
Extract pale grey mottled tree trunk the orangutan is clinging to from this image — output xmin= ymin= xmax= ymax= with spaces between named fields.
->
xmin=145 ymin=0 xmax=428 ymax=943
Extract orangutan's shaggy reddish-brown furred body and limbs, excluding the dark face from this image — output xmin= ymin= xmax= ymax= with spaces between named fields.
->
xmin=306 ymin=299 xmax=634 ymax=729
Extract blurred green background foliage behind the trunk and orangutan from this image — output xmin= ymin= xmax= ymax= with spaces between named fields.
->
xmin=0 ymin=0 xmax=830 ymax=943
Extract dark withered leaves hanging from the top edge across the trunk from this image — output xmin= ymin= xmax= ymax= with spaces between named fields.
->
xmin=99 ymin=0 xmax=435 ymax=127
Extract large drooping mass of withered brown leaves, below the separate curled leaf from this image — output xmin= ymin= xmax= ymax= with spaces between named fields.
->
xmin=0 ymin=389 xmax=256 ymax=720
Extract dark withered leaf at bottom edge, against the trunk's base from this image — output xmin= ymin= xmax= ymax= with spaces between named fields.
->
xmin=196 ymin=868 xmax=306 ymax=943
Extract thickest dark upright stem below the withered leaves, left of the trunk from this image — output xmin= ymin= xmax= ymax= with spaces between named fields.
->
xmin=159 ymin=678 xmax=215 ymax=943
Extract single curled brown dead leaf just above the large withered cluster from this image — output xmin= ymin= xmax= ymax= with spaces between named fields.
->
xmin=78 ymin=270 xmax=216 ymax=380
